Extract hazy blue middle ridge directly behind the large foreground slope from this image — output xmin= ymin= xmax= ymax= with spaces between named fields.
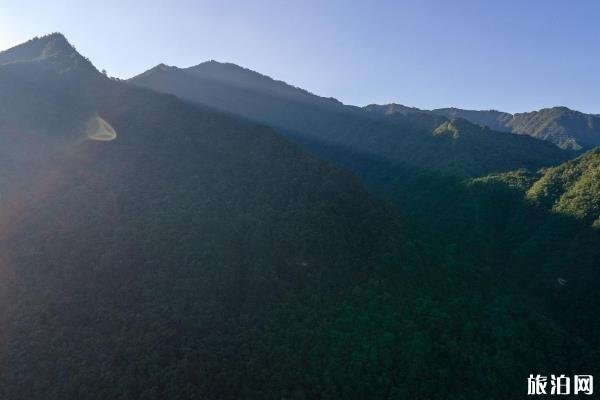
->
xmin=130 ymin=61 xmax=570 ymax=177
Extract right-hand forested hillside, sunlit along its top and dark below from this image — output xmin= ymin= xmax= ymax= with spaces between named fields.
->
xmin=384 ymin=154 xmax=600 ymax=354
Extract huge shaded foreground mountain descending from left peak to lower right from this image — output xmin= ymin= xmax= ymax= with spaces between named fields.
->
xmin=0 ymin=34 xmax=594 ymax=400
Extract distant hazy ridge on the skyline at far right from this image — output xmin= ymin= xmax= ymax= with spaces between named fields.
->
xmin=365 ymin=103 xmax=600 ymax=150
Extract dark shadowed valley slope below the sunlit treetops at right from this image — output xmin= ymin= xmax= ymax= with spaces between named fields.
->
xmin=286 ymin=130 xmax=600 ymax=345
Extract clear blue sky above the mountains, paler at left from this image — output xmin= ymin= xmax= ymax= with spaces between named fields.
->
xmin=0 ymin=0 xmax=600 ymax=113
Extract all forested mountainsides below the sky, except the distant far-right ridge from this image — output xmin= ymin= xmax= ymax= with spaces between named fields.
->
xmin=0 ymin=34 xmax=600 ymax=400
